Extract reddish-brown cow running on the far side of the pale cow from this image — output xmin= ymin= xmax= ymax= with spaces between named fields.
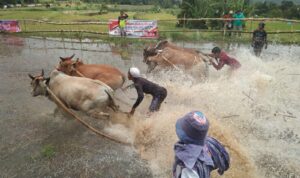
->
xmin=57 ymin=54 xmax=125 ymax=90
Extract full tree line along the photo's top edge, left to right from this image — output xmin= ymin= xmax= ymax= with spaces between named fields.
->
xmin=0 ymin=0 xmax=300 ymax=20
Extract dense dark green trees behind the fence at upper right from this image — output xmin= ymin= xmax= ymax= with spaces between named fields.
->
xmin=177 ymin=0 xmax=300 ymax=29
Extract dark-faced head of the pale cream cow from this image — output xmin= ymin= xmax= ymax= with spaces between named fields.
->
xmin=28 ymin=70 xmax=50 ymax=97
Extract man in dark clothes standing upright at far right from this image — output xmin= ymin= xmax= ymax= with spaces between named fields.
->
xmin=251 ymin=22 xmax=268 ymax=56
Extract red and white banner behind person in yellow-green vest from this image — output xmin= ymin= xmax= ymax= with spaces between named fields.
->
xmin=109 ymin=20 xmax=158 ymax=38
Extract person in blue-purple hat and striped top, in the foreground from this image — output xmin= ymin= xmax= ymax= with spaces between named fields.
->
xmin=173 ymin=111 xmax=230 ymax=178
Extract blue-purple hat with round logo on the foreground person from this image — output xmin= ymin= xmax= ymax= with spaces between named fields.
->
xmin=176 ymin=111 xmax=209 ymax=145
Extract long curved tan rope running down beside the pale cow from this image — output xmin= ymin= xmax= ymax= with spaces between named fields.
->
xmin=46 ymin=87 xmax=131 ymax=145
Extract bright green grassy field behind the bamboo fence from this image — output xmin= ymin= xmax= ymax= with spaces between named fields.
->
xmin=0 ymin=5 xmax=300 ymax=44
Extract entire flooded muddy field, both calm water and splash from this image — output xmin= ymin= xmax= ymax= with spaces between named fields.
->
xmin=0 ymin=36 xmax=300 ymax=177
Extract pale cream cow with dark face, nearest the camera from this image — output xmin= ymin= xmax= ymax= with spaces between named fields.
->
xmin=28 ymin=70 xmax=117 ymax=116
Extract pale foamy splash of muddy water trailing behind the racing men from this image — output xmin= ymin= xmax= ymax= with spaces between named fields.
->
xmin=129 ymin=43 xmax=300 ymax=177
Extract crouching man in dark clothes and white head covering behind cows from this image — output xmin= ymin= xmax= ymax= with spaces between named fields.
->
xmin=128 ymin=67 xmax=167 ymax=115
